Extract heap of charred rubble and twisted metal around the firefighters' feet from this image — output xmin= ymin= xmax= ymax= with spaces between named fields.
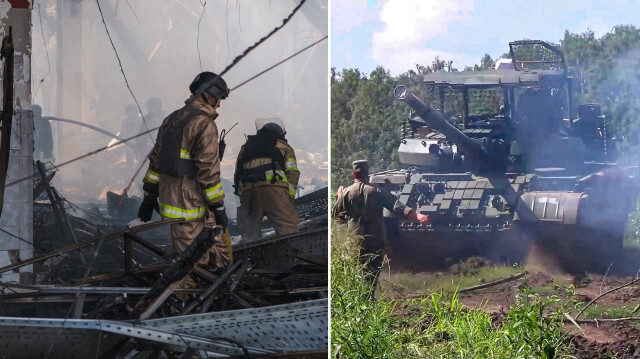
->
xmin=0 ymin=162 xmax=328 ymax=358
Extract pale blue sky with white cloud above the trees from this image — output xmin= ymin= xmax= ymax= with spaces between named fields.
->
xmin=330 ymin=0 xmax=640 ymax=76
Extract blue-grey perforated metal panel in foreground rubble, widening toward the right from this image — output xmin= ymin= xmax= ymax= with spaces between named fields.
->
xmin=142 ymin=299 xmax=329 ymax=351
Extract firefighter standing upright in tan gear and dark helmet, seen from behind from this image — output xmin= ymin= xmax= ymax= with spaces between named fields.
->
xmin=138 ymin=72 xmax=232 ymax=268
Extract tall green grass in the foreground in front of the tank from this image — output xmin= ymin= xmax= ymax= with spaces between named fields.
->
xmin=331 ymin=227 xmax=571 ymax=359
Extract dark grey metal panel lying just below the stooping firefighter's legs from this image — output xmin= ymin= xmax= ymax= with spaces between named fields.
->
xmin=233 ymin=228 xmax=329 ymax=269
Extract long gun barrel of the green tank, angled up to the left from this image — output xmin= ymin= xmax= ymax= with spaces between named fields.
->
xmin=394 ymin=85 xmax=481 ymax=161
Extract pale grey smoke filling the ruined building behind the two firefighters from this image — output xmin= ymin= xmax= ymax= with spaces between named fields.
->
xmin=32 ymin=0 xmax=328 ymax=204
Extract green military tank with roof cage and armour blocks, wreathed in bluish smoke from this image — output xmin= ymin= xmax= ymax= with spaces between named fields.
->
xmin=378 ymin=41 xmax=638 ymax=271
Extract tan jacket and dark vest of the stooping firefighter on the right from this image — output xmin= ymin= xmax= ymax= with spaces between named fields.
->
xmin=234 ymin=131 xmax=300 ymax=198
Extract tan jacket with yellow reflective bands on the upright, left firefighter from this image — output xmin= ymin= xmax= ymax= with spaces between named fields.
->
xmin=143 ymin=96 xmax=224 ymax=220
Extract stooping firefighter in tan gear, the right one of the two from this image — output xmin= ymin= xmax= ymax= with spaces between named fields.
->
xmin=234 ymin=118 xmax=300 ymax=239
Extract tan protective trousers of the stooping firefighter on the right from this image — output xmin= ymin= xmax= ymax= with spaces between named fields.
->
xmin=238 ymin=186 xmax=300 ymax=239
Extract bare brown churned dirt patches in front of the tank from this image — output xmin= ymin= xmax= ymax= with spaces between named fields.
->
xmin=382 ymin=245 xmax=640 ymax=359
